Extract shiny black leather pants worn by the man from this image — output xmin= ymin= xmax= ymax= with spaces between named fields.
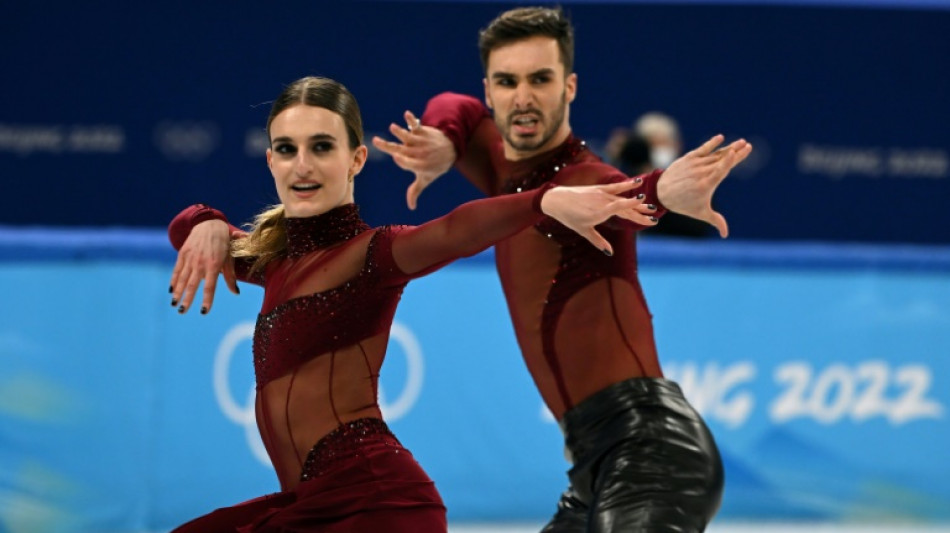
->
xmin=542 ymin=378 xmax=723 ymax=533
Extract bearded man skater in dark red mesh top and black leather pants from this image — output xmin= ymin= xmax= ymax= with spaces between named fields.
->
xmin=373 ymin=7 xmax=752 ymax=533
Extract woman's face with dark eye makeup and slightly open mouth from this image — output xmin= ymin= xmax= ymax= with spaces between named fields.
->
xmin=267 ymin=104 xmax=366 ymax=218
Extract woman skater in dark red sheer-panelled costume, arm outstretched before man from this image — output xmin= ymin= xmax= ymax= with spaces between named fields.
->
xmin=169 ymin=77 xmax=653 ymax=533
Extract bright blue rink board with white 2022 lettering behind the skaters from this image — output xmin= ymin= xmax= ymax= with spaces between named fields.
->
xmin=0 ymin=229 xmax=950 ymax=532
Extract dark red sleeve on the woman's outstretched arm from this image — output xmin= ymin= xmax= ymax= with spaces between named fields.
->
xmin=384 ymin=183 xmax=554 ymax=282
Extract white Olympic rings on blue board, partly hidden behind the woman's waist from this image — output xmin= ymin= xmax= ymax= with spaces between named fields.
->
xmin=212 ymin=322 xmax=425 ymax=465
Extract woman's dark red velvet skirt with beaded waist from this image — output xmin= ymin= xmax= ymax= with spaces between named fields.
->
xmin=173 ymin=418 xmax=448 ymax=533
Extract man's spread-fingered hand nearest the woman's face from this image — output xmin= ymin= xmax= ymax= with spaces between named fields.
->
xmin=373 ymin=111 xmax=456 ymax=209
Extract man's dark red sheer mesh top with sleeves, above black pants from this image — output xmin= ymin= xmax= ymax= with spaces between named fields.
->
xmin=422 ymin=93 xmax=664 ymax=419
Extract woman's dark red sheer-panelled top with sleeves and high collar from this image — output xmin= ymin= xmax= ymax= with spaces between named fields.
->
xmin=169 ymin=190 xmax=544 ymax=490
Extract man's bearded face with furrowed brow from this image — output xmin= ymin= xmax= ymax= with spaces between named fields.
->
xmin=484 ymin=37 xmax=577 ymax=160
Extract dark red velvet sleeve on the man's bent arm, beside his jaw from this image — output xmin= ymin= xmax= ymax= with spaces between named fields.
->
xmin=421 ymin=92 xmax=503 ymax=196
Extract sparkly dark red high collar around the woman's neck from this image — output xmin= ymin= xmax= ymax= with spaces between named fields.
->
xmin=286 ymin=204 xmax=369 ymax=258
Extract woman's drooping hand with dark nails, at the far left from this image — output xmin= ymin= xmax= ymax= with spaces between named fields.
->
xmin=169 ymin=220 xmax=241 ymax=314
